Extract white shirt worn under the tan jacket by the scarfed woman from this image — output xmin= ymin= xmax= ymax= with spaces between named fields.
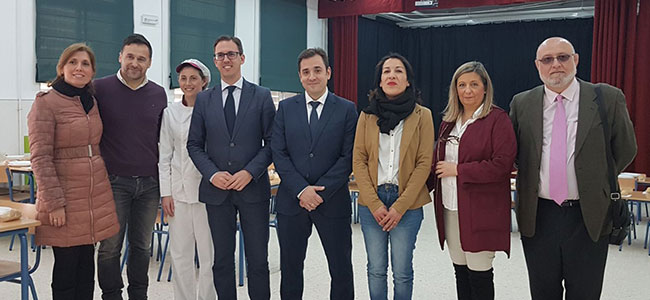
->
xmin=377 ymin=120 xmax=404 ymax=185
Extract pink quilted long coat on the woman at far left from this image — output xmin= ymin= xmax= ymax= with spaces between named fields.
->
xmin=27 ymin=90 xmax=120 ymax=247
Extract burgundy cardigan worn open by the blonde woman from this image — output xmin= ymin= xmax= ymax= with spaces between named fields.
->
xmin=427 ymin=107 xmax=517 ymax=255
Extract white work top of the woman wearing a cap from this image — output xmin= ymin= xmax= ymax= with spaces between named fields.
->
xmin=158 ymin=102 xmax=201 ymax=203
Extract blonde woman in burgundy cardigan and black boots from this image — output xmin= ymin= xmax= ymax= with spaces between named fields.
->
xmin=428 ymin=62 xmax=517 ymax=300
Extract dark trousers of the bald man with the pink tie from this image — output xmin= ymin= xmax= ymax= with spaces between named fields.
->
xmin=521 ymin=199 xmax=608 ymax=300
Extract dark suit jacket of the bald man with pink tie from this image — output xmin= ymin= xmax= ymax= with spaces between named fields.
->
xmin=510 ymin=80 xmax=637 ymax=241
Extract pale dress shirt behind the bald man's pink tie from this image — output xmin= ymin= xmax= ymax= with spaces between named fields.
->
xmin=538 ymin=78 xmax=580 ymax=199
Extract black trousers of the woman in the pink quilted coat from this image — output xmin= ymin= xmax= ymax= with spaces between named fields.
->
xmin=52 ymin=245 xmax=95 ymax=300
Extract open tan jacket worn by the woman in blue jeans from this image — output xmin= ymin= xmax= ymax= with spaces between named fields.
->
xmin=353 ymin=104 xmax=435 ymax=214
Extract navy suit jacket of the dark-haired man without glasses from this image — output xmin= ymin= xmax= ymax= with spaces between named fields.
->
xmin=271 ymin=93 xmax=357 ymax=218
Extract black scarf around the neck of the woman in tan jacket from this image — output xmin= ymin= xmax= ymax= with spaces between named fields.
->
xmin=363 ymin=87 xmax=416 ymax=134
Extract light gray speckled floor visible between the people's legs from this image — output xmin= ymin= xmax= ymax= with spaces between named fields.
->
xmin=0 ymin=205 xmax=650 ymax=300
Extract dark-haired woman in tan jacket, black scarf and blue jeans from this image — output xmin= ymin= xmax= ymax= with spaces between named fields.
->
xmin=352 ymin=54 xmax=434 ymax=300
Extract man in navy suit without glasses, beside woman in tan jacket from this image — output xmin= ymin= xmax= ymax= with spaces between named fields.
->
xmin=271 ymin=48 xmax=357 ymax=300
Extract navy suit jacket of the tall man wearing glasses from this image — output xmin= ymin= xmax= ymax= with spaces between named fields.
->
xmin=187 ymin=80 xmax=275 ymax=205
